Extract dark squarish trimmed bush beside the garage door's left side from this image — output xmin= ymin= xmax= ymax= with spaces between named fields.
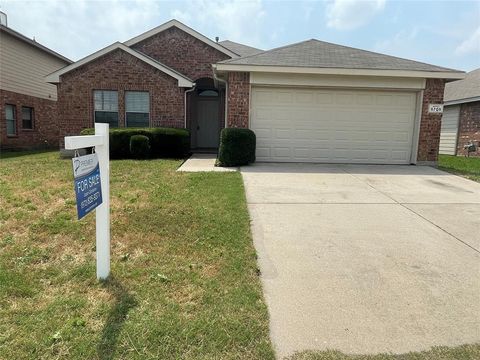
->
xmin=217 ymin=128 xmax=256 ymax=166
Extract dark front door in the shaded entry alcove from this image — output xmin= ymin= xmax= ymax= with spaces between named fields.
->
xmin=196 ymin=99 xmax=220 ymax=148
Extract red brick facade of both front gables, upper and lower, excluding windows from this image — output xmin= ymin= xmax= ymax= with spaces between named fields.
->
xmin=57 ymin=27 xmax=229 ymax=143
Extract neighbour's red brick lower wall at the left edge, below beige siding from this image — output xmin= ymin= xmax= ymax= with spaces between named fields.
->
xmin=0 ymin=90 xmax=58 ymax=149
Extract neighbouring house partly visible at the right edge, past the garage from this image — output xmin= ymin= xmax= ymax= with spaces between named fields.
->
xmin=440 ymin=69 xmax=480 ymax=156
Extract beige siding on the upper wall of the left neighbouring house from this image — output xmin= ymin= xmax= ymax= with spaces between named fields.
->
xmin=0 ymin=32 xmax=67 ymax=100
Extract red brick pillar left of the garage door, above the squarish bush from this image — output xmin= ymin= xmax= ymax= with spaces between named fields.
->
xmin=227 ymin=72 xmax=250 ymax=128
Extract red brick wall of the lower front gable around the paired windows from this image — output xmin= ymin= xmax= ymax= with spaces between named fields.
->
xmin=58 ymin=50 xmax=185 ymax=141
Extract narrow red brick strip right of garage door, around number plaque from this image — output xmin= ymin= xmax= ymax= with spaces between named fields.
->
xmin=417 ymin=79 xmax=445 ymax=162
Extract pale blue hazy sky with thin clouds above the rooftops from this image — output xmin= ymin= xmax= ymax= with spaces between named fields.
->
xmin=0 ymin=0 xmax=480 ymax=71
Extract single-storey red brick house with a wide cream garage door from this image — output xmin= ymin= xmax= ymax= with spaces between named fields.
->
xmin=47 ymin=20 xmax=464 ymax=164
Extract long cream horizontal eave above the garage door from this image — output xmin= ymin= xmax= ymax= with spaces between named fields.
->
xmin=214 ymin=63 xmax=465 ymax=80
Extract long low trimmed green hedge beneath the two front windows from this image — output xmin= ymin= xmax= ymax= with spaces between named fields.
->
xmin=81 ymin=128 xmax=190 ymax=159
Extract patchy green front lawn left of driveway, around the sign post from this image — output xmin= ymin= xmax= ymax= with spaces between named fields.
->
xmin=0 ymin=152 xmax=273 ymax=359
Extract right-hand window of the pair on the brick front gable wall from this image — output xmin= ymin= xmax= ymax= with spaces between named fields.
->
xmin=125 ymin=91 xmax=150 ymax=127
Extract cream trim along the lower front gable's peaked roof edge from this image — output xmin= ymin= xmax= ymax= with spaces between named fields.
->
xmin=46 ymin=42 xmax=194 ymax=87
